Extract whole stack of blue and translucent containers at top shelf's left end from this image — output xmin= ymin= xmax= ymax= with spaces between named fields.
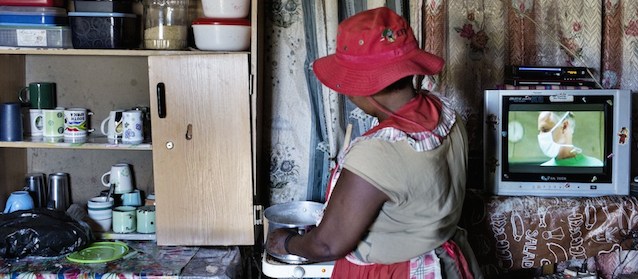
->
xmin=0 ymin=0 xmax=72 ymax=48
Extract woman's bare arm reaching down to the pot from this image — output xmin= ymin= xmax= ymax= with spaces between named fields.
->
xmin=266 ymin=169 xmax=388 ymax=261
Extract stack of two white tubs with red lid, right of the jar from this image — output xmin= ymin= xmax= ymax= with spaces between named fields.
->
xmin=193 ymin=0 xmax=251 ymax=51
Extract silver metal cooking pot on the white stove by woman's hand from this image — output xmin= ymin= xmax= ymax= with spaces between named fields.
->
xmin=264 ymin=201 xmax=323 ymax=264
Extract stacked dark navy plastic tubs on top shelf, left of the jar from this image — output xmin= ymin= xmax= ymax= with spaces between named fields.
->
xmin=69 ymin=0 xmax=141 ymax=49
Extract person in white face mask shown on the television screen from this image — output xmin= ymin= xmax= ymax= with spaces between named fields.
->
xmin=538 ymin=111 xmax=603 ymax=167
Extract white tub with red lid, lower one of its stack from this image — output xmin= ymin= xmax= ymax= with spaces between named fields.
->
xmin=193 ymin=18 xmax=250 ymax=51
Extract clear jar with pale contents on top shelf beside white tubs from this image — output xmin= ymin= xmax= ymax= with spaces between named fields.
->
xmin=144 ymin=0 xmax=189 ymax=49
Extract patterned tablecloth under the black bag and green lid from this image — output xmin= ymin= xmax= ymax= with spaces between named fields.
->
xmin=0 ymin=241 xmax=241 ymax=279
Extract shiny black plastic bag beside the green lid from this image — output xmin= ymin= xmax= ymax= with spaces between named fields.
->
xmin=0 ymin=208 xmax=92 ymax=258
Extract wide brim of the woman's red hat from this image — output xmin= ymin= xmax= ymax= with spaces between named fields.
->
xmin=312 ymin=48 xmax=445 ymax=96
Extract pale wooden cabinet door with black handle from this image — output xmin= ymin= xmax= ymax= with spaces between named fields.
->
xmin=149 ymin=53 xmax=254 ymax=245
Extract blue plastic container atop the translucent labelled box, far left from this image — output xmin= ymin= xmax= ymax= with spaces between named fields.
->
xmin=0 ymin=6 xmax=68 ymax=26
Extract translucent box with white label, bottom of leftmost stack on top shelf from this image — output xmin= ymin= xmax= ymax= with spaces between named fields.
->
xmin=0 ymin=26 xmax=73 ymax=48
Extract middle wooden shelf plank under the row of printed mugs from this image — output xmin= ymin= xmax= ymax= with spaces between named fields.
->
xmin=0 ymin=137 xmax=152 ymax=150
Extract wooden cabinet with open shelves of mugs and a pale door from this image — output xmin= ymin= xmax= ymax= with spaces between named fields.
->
xmin=0 ymin=0 xmax=262 ymax=246
